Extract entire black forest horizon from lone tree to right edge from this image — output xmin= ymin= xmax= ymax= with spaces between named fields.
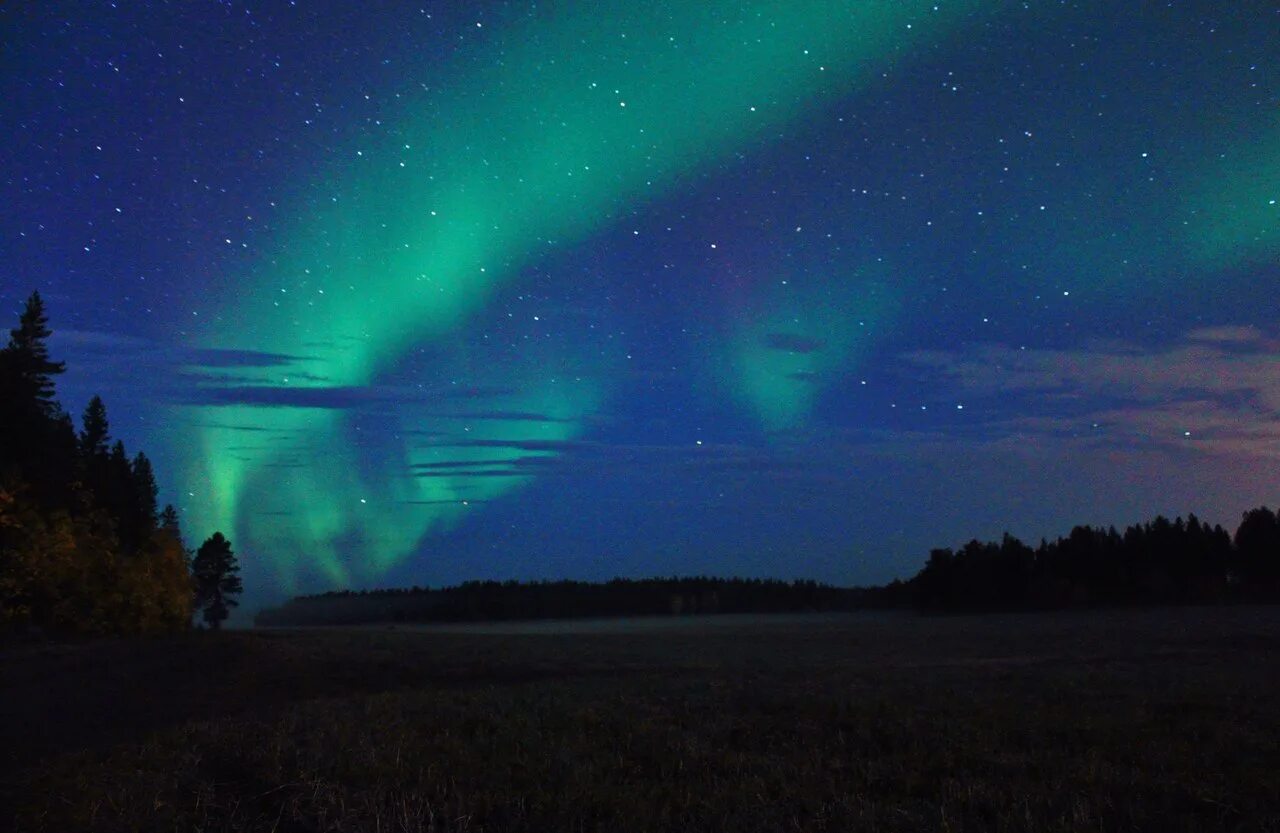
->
xmin=255 ymin=507 xmax=1280 ymax=626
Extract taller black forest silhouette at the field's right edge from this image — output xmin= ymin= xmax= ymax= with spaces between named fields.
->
xmin=901 ymin=507 xmax=1280 ymax=610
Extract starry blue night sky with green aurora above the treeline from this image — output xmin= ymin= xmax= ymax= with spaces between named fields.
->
xmin=0 ymin=0 xmax=1280 ymax=611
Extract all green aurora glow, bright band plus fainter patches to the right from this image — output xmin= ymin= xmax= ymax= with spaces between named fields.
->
xmin=165 ymin=0 xmax=1280 ymax=592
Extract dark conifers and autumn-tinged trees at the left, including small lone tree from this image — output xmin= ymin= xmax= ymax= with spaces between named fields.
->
xmin=0 ymin=293 xmax=242 ymax=635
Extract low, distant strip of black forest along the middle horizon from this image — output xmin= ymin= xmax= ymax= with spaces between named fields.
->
xmin=255 ymin=576 xmax=873 ymax=626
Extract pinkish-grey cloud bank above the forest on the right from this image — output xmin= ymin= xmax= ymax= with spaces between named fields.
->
xmin=902 ymin=326 xmax=1280 ymax=458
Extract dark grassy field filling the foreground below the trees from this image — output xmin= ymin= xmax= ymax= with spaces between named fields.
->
xmin=0 ymin=608 xmax=1280 ymax=832
